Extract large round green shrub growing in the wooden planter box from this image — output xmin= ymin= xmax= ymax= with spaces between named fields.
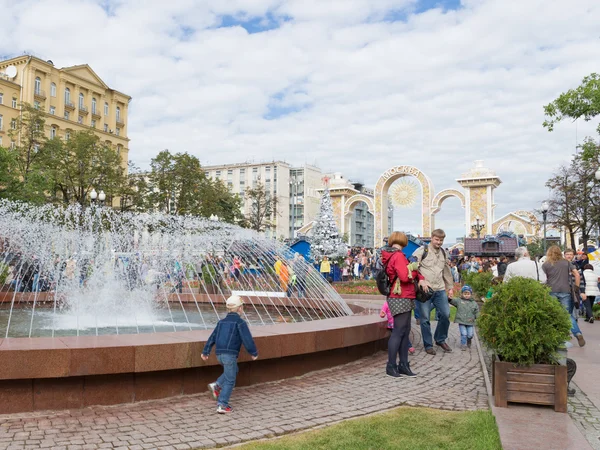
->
xmin=477 ymin=277 xmax=571 ymax=366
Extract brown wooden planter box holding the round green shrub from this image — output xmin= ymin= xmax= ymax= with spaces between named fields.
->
xmin=492 ymin=360 xmax=567 ymax=412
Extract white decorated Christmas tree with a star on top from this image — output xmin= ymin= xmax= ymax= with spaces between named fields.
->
xmin=310 ymin=187 xmax=348 ymax=261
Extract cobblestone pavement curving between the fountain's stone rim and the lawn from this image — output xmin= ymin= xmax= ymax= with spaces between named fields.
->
xmin=0 ymin=323 xmax=487 ymax=450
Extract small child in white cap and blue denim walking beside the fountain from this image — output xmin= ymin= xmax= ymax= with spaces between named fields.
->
xmin=202 ymin=295 xmax=258 ymax=414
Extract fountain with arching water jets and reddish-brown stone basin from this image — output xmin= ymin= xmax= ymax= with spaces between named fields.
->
xmin=0 ymin=201 xmax=385 ymax=413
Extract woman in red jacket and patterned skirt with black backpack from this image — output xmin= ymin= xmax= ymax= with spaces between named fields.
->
xmin=381 ymin=231 xmax=423 ymax=377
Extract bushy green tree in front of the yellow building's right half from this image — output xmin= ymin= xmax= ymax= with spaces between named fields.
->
xmin=43 ymin=131 xmax=125 ymax=205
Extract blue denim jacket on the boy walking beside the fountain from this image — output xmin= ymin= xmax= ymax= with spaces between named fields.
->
xmin=202 ymin=312 xmax=258 ymax=356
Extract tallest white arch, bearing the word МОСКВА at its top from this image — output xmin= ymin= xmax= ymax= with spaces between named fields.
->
xmin=375 ymin=166 xmax=433 ymax=246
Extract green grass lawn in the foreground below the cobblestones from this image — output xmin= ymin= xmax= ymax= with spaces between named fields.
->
xmin=234 ymin=406 xmax=502 ymax=450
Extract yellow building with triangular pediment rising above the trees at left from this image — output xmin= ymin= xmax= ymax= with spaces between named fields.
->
xmin=0 ymin=55 xmax=131 ymax=169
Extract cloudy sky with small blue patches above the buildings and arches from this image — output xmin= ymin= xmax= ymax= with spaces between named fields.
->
xmin=0 ymin=0 xmax=600 ymax=240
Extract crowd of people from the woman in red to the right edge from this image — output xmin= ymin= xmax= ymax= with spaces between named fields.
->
xmin=381 ymin=229 xmax=584 ymax=395
